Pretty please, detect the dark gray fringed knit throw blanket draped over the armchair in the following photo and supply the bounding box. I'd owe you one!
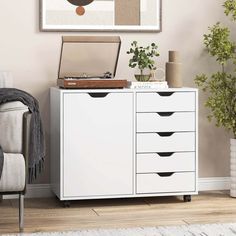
[0,88,45,183]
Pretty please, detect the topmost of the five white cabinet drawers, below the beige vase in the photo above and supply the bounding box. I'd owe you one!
[137,92,196,112]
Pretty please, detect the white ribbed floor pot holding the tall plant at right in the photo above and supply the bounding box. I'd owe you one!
[230,139,236,197]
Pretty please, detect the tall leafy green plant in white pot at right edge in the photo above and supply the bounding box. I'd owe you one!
[195,0,236,197]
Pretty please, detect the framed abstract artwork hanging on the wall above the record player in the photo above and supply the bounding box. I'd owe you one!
[40,0,161,31]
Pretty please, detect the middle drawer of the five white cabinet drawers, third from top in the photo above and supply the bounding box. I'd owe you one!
[137,132,195,153]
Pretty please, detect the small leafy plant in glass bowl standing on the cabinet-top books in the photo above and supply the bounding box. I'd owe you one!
[127,41,160,81]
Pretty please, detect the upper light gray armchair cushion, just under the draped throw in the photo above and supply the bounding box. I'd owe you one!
[0,102,28,153]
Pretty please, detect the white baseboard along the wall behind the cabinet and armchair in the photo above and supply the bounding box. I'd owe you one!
[1,177,230,199]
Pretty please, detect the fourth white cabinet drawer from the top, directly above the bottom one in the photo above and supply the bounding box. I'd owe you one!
[137,152,195,173]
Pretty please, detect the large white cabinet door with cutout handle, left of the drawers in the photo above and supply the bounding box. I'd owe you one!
[63,93,133,197]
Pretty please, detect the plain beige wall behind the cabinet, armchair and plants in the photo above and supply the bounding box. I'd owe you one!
[0,0,232,183]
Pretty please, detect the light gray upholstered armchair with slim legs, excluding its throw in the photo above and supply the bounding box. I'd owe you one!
[0,102,31,230]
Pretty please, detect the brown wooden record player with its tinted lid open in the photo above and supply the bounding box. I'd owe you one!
[57,36,128,89]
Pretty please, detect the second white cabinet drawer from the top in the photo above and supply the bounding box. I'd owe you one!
[137,112,195,132]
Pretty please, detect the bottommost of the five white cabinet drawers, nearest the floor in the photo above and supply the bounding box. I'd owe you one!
[137,172,196,193]
